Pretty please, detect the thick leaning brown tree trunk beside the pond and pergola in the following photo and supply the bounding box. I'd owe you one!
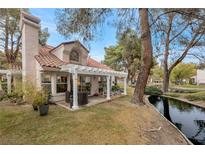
[132,8,152,105]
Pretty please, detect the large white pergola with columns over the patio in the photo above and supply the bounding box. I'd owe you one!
[61,64,128,109]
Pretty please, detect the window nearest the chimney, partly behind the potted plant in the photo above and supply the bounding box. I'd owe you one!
[41,73,51,93]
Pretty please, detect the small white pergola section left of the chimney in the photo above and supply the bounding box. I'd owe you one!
[0,70,21,93]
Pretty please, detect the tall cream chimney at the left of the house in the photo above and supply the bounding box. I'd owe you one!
[20,12,40,85]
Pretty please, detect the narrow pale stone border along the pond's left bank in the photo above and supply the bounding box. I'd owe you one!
[145,96,193,145]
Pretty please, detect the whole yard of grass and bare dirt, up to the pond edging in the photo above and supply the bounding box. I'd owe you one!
[0,93,186,144]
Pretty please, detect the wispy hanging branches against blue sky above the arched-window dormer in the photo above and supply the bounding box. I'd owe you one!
[56,8,112,41]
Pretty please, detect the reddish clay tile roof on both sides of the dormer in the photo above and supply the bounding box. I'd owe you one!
[35,45,112,70]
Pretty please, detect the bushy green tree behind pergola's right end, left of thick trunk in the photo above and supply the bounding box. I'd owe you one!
[104,29,141,79]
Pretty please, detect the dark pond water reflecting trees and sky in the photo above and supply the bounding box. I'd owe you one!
[149,96,205,145]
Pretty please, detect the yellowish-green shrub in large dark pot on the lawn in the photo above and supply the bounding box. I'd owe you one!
[33,90,49,116]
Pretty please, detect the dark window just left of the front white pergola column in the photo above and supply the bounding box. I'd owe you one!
[56,75,67,93]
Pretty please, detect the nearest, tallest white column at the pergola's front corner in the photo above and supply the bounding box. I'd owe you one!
[72,72,79,109]
